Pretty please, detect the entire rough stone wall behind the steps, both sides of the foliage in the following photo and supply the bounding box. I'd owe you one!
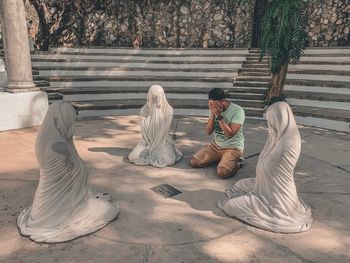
[0,0,350,48]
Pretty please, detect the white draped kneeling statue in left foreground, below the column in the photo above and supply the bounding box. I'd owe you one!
[17,101,119,243]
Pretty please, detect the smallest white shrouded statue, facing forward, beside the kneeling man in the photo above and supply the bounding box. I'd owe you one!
[129,85,182,167]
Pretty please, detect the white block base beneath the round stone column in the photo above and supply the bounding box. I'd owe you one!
[0,91,49,131]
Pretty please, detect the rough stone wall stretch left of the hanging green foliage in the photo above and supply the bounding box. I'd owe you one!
[26,0,253,48]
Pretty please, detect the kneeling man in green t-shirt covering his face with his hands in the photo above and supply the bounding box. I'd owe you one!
[191,88,245,178]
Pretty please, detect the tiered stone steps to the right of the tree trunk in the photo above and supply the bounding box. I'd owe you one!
[285,48,350,132]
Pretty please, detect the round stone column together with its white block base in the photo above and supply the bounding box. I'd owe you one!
[0,0,48,131]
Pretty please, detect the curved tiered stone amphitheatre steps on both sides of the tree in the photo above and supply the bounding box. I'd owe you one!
[32,47,350,131]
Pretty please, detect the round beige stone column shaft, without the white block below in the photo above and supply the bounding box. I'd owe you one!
[1,0,39,93]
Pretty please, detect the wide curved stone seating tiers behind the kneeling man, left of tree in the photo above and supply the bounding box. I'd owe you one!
[32,47,263,118]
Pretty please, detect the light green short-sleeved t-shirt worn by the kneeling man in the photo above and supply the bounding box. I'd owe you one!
[214,102,245,151]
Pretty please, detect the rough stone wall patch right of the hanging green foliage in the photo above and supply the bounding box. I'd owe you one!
[307,0,350,47]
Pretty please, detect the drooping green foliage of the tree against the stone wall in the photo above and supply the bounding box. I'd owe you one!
[260,0,309,74]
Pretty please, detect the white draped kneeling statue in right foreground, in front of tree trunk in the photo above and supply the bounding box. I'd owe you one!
[217,102,313,233]
